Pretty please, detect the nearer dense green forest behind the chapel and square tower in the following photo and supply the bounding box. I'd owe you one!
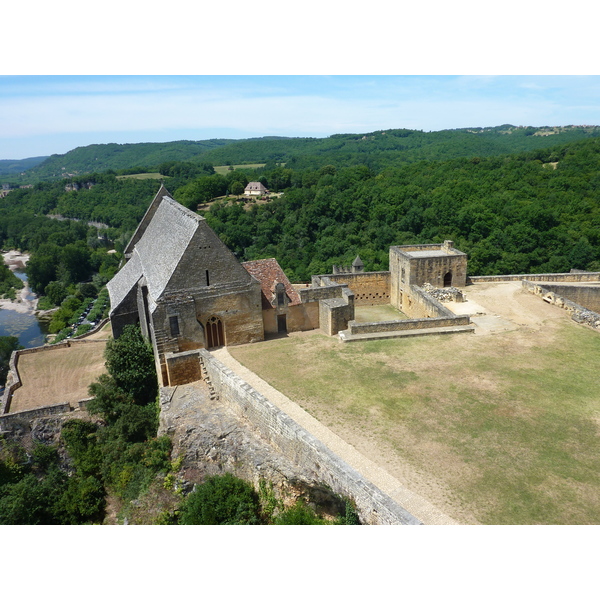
[0,136,600,281]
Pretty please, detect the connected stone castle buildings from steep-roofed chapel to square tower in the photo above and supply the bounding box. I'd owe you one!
[108,184,472,386]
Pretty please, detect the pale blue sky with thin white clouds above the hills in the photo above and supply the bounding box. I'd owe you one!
[0,75,600,159]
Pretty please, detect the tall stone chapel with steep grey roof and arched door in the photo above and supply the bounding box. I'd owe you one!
[107,186,264,385]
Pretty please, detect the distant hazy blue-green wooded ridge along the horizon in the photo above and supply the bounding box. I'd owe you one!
[0,125,600,183]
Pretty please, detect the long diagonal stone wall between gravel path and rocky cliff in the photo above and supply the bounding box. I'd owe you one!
[198,350,421,525]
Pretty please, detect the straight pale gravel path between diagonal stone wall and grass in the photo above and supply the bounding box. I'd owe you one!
[212,348,458,525]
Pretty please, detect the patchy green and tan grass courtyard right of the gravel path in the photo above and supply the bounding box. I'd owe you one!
[229,284,600,524]
